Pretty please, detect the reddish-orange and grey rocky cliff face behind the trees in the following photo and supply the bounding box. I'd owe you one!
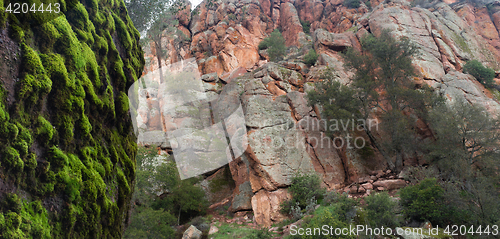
[139,0,500,226]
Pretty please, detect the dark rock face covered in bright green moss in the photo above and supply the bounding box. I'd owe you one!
[0,0,144,238]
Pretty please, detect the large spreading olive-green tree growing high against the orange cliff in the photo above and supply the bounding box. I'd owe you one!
[308,30,440,172]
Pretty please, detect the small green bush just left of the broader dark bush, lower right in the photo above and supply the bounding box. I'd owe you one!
[364,192,399,228]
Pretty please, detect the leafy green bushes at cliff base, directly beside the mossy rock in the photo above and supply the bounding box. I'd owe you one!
[126,147,208,238]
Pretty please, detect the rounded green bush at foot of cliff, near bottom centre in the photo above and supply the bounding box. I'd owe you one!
[281,174,325,216]
